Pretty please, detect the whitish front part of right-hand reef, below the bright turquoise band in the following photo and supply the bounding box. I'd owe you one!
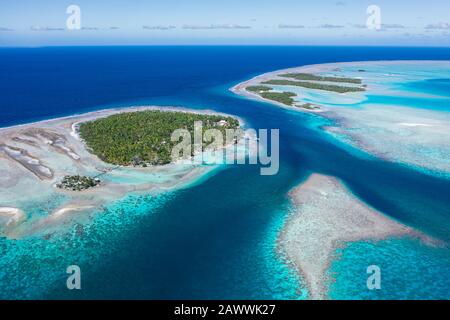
[325,104,450,177]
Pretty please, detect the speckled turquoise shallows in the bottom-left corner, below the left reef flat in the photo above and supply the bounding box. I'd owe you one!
[0,194,171,299]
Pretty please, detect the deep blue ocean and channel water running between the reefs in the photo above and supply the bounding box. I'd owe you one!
[0,46,450,299]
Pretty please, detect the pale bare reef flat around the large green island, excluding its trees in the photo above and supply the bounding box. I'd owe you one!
[0,106,241,239]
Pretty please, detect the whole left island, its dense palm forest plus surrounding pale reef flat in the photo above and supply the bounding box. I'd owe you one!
[0,106,241,239]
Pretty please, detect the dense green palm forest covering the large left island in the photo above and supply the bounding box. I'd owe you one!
[79,110,239,167]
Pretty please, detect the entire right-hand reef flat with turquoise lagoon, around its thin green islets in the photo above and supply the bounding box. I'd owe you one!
[231,61,450,176]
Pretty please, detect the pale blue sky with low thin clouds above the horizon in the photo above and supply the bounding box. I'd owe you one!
[0,0,450,46]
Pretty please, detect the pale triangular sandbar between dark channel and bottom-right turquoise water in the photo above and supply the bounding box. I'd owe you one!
[279,174,434,300]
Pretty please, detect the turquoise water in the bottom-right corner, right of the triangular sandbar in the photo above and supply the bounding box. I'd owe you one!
[329,238,450,300]
